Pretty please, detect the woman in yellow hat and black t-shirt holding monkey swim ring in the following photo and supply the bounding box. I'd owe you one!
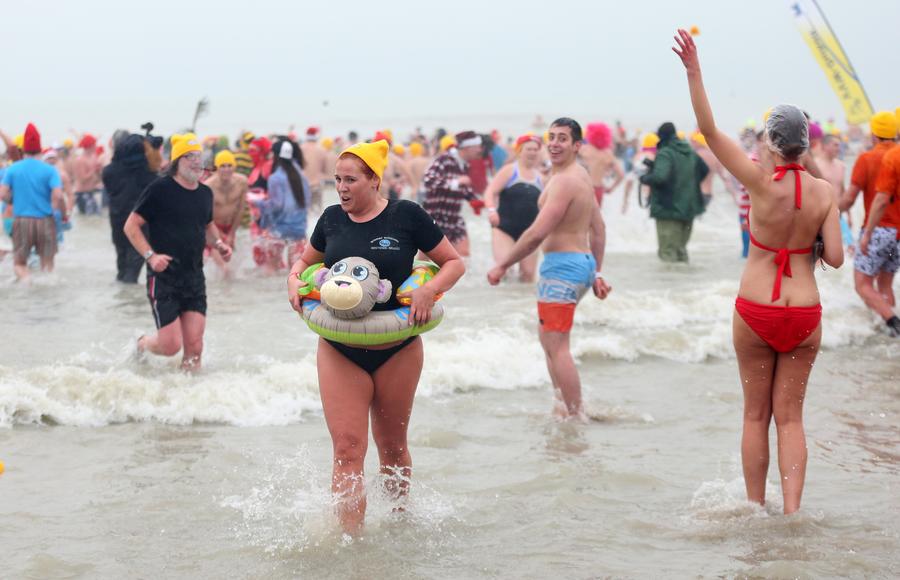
[287,140,465,534]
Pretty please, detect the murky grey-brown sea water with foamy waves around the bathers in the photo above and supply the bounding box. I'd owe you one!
[0,184,900,578]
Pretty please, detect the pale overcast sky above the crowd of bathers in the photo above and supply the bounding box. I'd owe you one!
[0,0,900,140]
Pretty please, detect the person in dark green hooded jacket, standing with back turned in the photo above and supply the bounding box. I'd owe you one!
[641,123,709,262]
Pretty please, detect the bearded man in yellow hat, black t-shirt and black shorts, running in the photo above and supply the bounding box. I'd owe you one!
[124,133,231,371]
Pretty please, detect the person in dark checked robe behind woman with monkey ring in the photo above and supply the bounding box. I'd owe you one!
[423,131,482,257]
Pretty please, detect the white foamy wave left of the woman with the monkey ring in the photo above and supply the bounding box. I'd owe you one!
[0,356,321,427]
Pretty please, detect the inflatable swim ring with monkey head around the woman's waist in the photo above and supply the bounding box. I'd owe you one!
[298,257,444,346]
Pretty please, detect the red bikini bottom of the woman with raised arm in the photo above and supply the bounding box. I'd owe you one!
[734,297,822,352]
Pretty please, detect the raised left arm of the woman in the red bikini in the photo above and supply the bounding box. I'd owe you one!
[672,28,765,190]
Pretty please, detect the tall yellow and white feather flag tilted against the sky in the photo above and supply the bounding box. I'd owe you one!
[789,0,874,125]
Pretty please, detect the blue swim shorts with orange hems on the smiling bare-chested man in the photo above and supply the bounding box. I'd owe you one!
[537,252,597,332]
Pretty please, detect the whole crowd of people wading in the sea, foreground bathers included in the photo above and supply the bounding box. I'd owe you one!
[0,31,900,531]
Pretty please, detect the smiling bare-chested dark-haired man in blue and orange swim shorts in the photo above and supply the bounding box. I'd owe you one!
[488,117,612,420]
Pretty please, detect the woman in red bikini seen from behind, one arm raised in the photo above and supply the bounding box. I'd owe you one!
[672,30,844,514]
